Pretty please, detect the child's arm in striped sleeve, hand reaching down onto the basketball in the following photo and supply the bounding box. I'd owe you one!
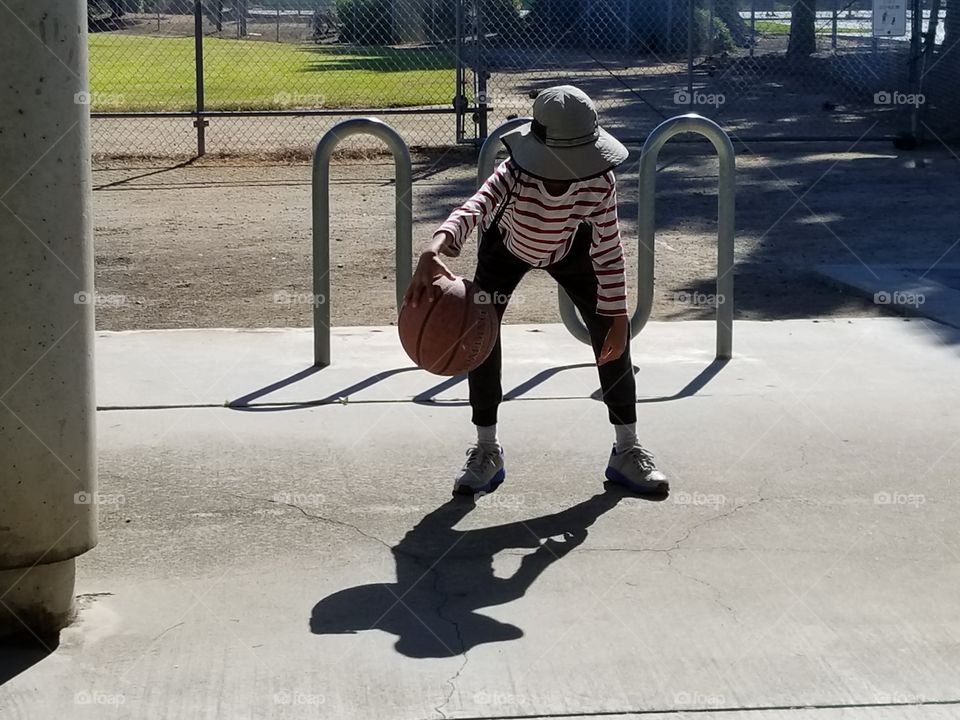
[405,160,516,307]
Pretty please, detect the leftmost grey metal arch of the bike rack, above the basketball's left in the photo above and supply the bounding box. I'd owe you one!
[313,118,413,367]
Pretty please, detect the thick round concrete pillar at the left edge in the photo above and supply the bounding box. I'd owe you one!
[0,0,97,638]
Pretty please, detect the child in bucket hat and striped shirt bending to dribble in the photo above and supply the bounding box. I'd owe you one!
[407,85,669,494]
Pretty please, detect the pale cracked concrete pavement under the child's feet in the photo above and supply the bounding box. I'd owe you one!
[0,318,960,720]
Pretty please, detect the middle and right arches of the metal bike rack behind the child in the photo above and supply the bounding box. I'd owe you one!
[478,113,736,358]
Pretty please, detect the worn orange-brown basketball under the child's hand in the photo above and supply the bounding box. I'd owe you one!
[397,277,500,375]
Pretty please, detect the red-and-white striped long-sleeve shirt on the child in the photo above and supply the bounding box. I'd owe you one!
[437,159,627,316]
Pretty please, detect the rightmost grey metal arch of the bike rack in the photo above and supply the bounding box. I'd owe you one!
[630,113,736,359]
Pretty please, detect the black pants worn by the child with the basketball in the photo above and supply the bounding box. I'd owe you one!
[468,224,637,426]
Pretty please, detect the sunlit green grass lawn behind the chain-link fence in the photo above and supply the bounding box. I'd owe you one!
[89,33,454,111]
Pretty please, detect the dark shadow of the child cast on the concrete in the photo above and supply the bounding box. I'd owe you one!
[310,484,665,658]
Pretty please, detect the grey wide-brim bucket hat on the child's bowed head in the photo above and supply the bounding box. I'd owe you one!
[502,85,629,181]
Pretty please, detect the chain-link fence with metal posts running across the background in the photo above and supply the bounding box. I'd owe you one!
[89,0,960,155]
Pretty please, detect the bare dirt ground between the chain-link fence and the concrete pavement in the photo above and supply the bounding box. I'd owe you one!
[93,143,960,330]
